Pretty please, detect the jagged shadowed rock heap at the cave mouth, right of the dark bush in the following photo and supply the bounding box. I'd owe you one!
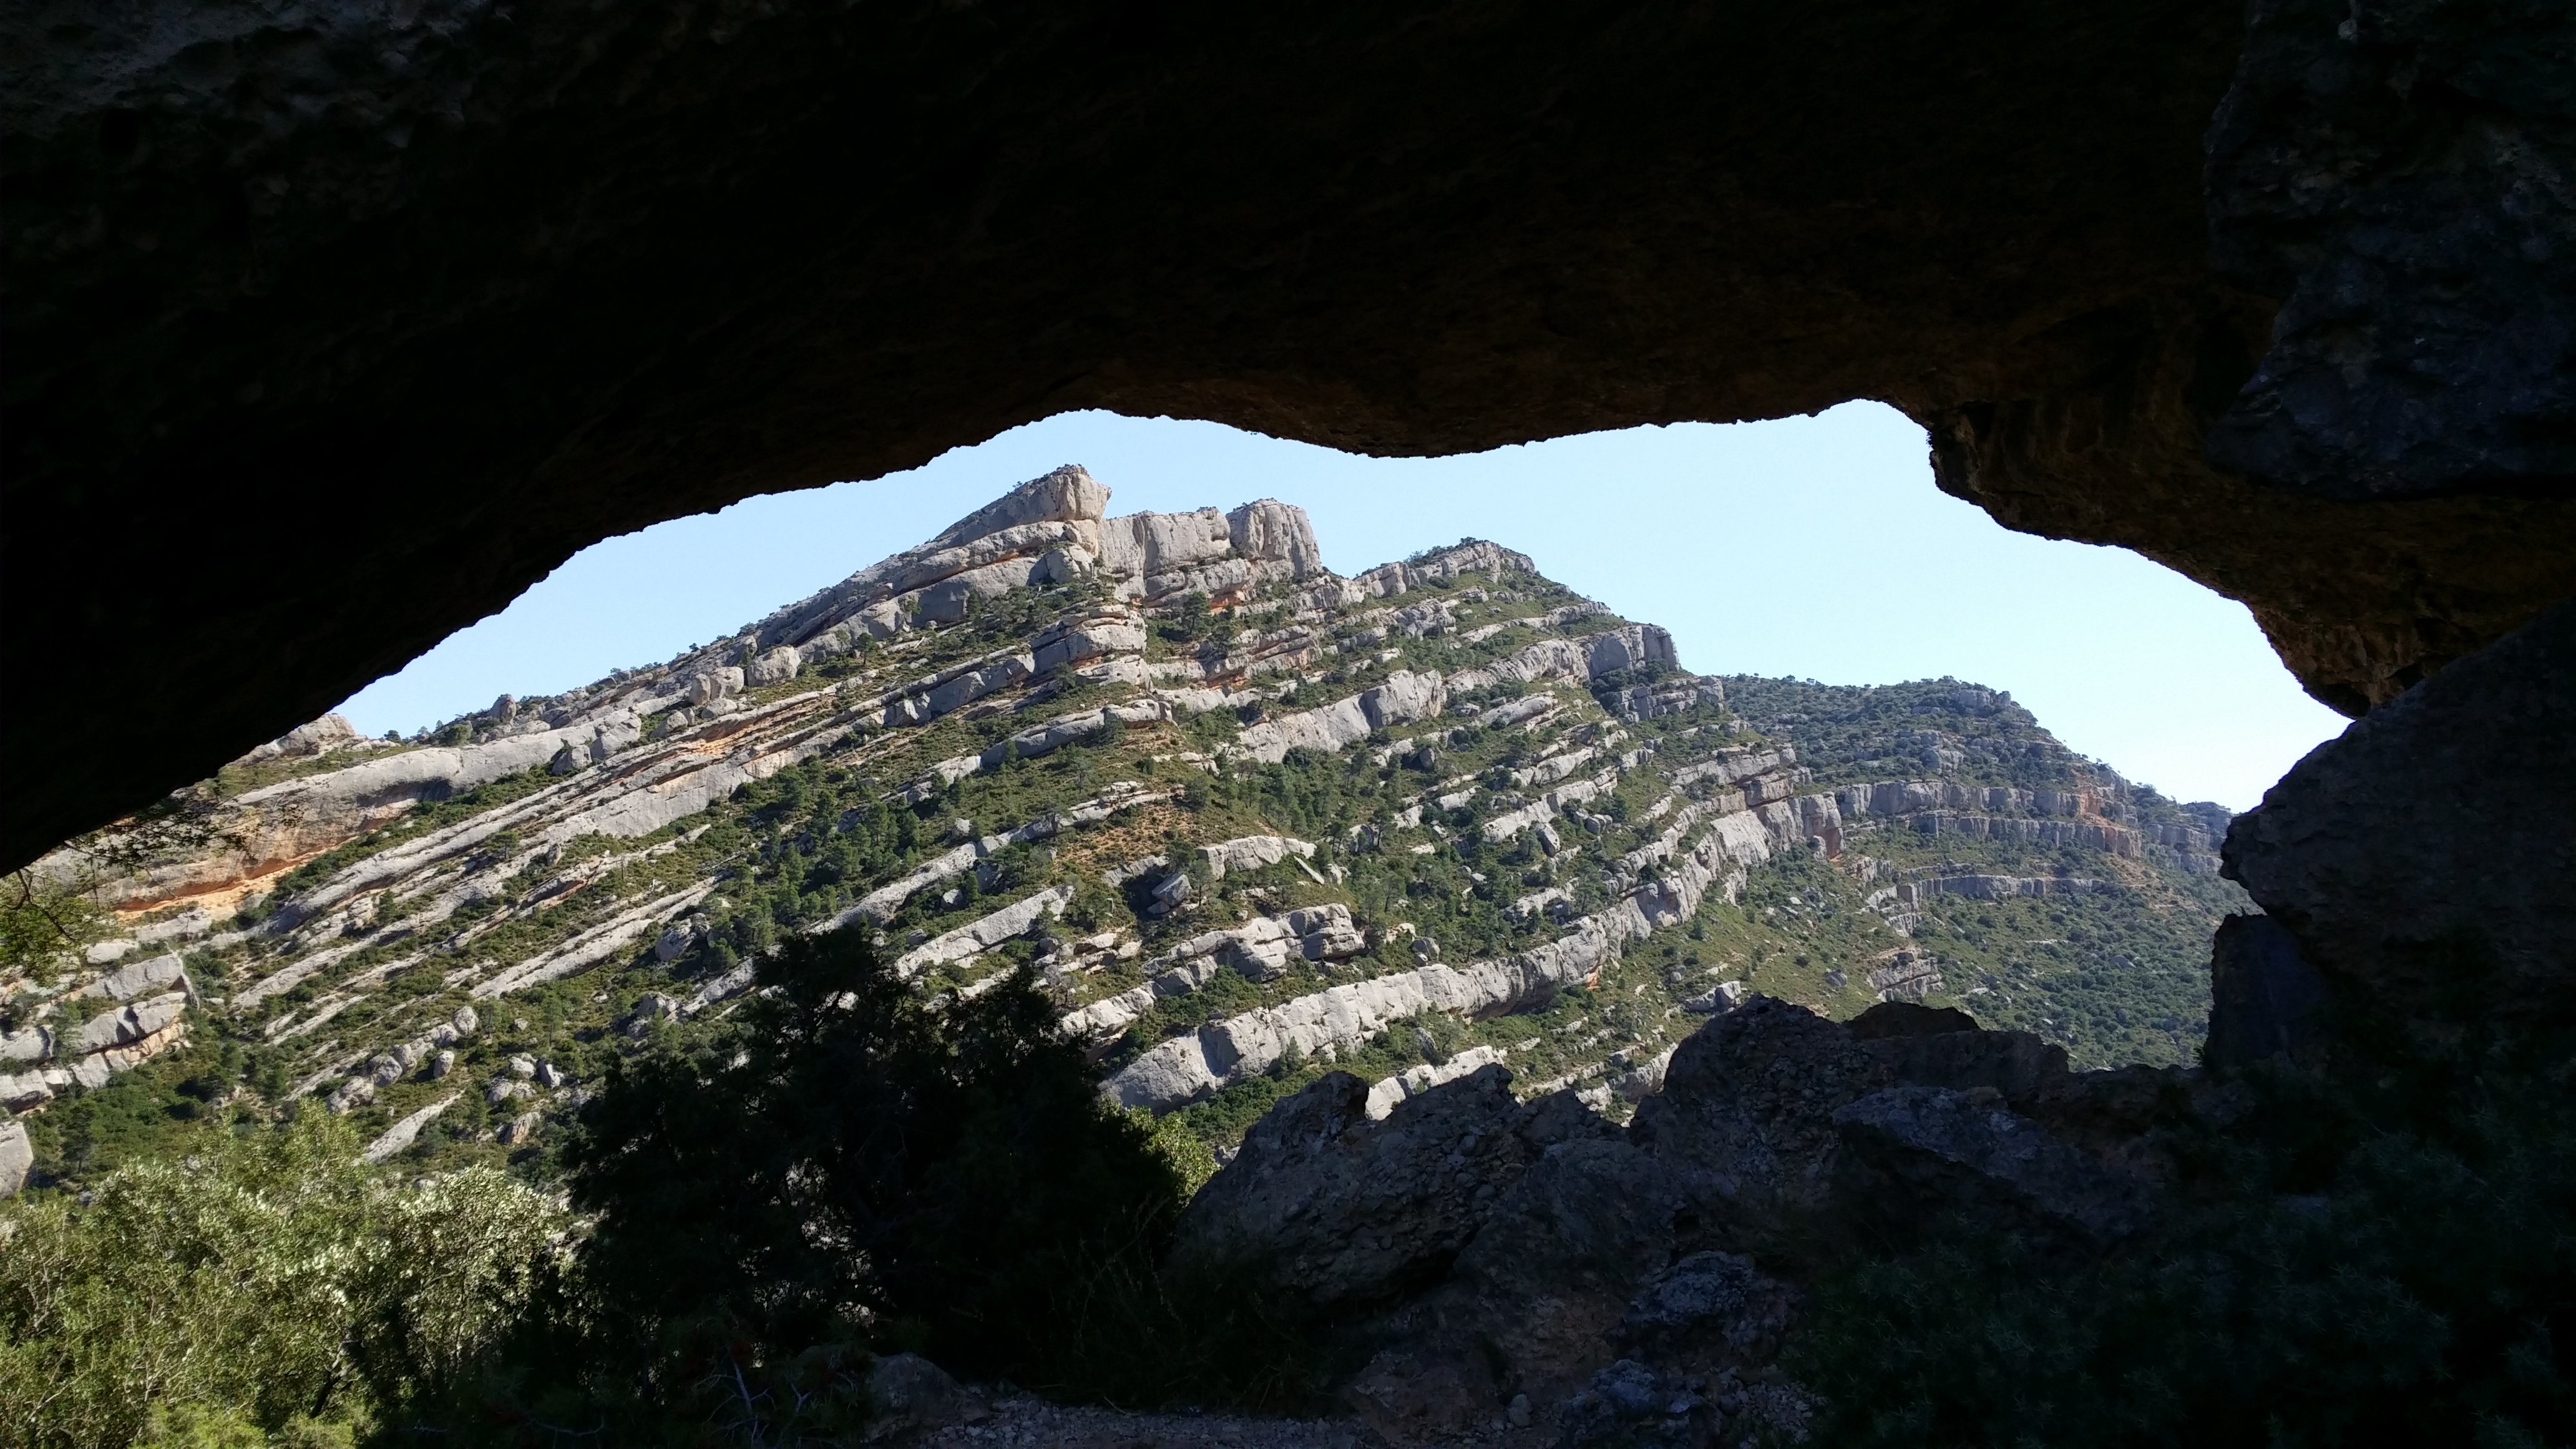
[1172,995,2205,1447]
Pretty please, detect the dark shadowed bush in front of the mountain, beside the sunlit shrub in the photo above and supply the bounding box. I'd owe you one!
[494,912,1306,1444]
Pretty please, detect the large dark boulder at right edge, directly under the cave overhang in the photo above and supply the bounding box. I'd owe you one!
[2220,601,2576,1023]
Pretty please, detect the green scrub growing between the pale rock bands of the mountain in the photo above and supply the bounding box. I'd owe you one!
[10,564,2238,1196]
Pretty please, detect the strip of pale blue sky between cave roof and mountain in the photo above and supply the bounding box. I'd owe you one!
[340,402,2344,809]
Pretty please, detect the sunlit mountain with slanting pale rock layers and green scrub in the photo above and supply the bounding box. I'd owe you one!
[0,467,2236,1176]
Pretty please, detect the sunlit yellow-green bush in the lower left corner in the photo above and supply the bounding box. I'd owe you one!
[0,1114,562,1449]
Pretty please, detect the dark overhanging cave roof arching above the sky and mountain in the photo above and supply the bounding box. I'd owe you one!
[0,0,2576,864]
